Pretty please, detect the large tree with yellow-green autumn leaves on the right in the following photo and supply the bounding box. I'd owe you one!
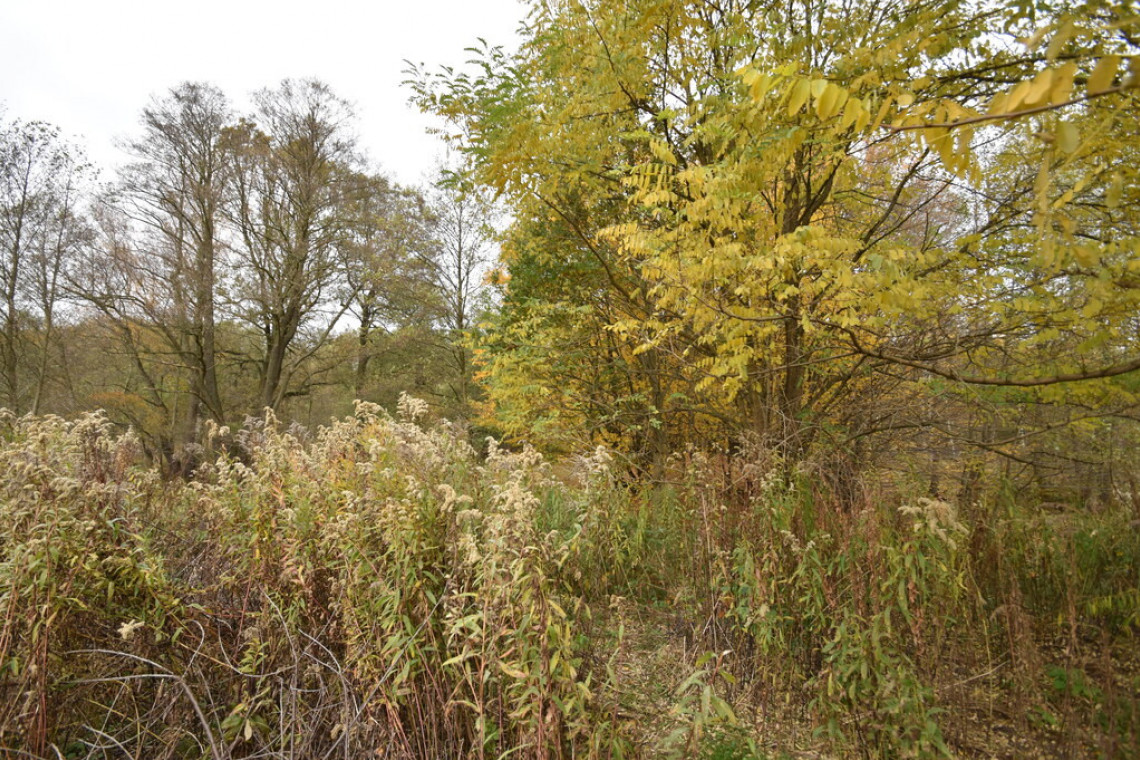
[417,0,1140,487]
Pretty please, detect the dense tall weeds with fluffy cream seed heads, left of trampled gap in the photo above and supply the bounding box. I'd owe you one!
[0,407,620,757]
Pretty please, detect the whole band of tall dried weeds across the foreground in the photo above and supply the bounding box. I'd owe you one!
[0,398,1140,758]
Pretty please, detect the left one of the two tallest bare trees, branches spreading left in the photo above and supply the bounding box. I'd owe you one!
[72,82,233,469]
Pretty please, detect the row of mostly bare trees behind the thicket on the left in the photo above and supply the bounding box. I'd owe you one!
[0,80,492,468]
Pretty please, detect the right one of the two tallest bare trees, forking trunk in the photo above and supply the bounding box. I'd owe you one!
[233,80,369,409]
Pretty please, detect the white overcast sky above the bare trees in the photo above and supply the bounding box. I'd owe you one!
[0,0,526,183]
